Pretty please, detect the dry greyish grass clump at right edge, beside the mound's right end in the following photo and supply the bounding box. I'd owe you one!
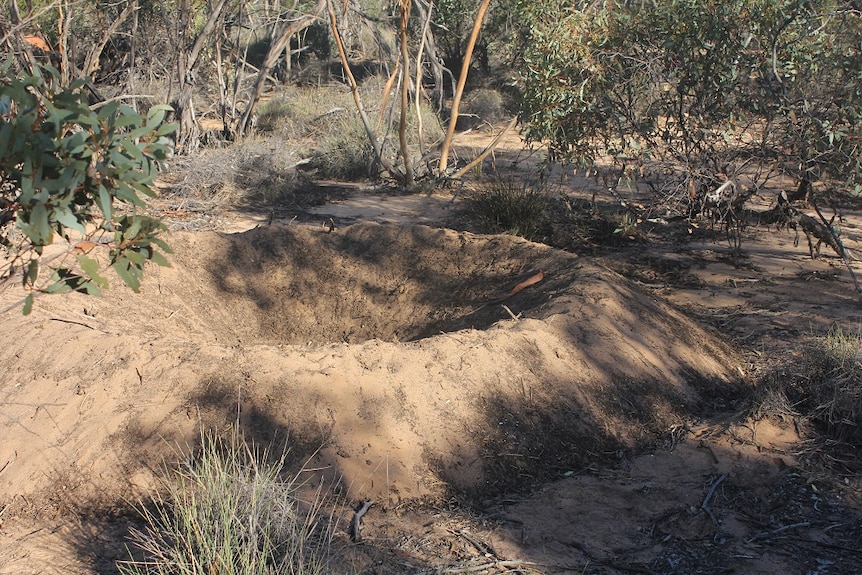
[757,327,862,447]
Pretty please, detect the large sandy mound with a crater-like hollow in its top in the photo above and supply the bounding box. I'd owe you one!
[0,224,739,506]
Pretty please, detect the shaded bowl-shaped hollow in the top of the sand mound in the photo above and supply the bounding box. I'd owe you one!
[160,224,577,344]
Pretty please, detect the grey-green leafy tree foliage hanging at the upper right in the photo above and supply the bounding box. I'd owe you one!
[519,0,862,205]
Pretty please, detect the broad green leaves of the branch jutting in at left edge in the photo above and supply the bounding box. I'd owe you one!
[0,60,174,313]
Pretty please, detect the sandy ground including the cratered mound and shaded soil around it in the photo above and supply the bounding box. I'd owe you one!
[0,133,862,575]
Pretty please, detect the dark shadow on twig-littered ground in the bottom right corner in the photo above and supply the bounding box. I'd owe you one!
[490,430,862,574]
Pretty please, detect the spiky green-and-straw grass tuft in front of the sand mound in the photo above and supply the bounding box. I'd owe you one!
[117,432,335,575]
